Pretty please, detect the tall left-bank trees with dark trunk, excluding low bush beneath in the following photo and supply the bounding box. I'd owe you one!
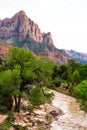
[0,47,54,112]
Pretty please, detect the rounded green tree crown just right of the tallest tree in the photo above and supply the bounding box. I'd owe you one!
[35,57,55,87]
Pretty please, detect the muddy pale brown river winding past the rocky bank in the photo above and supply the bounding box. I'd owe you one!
[51,91,87,130]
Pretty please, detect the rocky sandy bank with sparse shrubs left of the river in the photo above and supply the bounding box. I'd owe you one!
[0,95,63,130]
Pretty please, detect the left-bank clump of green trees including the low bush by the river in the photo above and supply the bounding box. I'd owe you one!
[0,47,54,112]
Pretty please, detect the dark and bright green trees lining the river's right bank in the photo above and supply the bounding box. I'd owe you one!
[52,60,87,111]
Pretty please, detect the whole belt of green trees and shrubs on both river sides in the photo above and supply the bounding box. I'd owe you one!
[0,47,87,130]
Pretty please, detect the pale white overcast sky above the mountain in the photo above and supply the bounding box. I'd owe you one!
[0,0,87,53]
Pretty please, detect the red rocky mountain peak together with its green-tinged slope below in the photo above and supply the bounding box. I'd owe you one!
[0,11,71,64]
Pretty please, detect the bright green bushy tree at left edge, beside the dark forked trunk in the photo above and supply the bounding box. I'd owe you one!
[0,69,20,110]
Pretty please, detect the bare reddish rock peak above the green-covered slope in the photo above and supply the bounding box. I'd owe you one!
[0,11,53,46]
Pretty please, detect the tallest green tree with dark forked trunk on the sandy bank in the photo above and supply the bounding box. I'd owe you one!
[5,47,35,112]
